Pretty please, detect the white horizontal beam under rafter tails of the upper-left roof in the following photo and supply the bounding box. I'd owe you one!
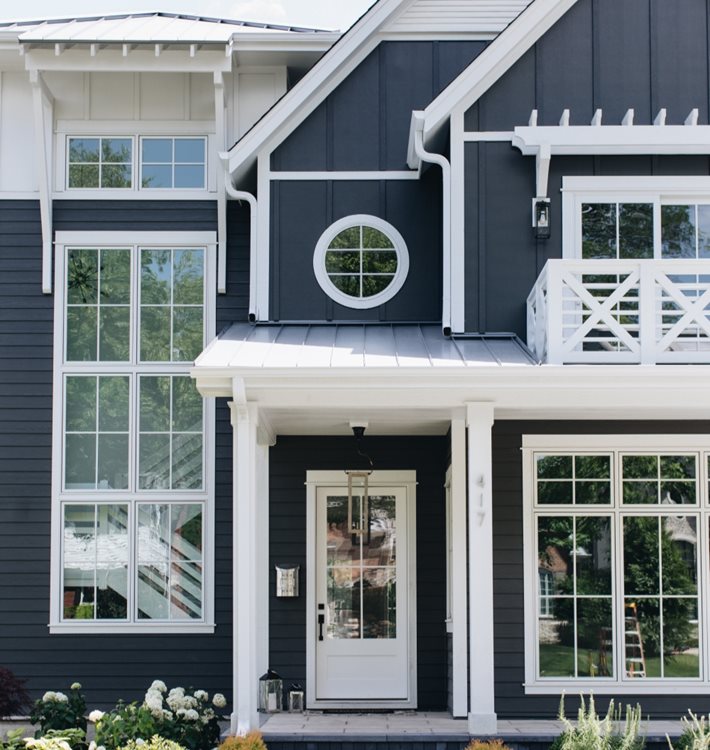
[25,43,232,73]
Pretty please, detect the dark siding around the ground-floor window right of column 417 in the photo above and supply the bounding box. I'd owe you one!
[493,421,710,719]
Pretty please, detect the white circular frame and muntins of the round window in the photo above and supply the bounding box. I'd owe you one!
[313,214,409,310]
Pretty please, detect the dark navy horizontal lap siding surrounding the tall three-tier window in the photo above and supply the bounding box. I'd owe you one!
[0,200,249,708]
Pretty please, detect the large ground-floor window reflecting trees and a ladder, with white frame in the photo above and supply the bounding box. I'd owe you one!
[523,435,710,694]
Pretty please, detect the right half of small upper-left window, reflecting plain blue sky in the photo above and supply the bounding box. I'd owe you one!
[140,136,207,190]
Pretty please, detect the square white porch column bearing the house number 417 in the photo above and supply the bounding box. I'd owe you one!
[466,403,497,734]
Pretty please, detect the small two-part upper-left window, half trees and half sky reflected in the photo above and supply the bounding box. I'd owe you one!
[64,134,208,193]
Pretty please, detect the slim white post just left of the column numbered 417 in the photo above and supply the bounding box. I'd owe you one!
[449,418,468,718]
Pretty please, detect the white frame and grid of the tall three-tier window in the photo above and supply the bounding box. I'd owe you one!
[50,232,217,633]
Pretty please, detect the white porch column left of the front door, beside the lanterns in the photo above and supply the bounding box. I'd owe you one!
[230,378,270,734]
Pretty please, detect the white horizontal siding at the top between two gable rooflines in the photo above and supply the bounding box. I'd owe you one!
[384,0,531,34]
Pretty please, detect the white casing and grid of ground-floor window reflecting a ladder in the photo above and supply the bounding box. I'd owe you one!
[523,434,710,695]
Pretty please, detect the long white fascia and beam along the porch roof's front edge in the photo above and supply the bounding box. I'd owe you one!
[190,365,710,420]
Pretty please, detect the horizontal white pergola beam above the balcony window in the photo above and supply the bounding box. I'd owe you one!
[512,125,710,156]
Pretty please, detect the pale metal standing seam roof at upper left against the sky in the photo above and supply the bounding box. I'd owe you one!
[0,12,330,44]
